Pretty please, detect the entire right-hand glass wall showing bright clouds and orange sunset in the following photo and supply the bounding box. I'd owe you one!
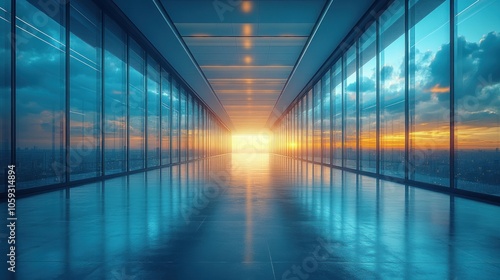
[273,0,500,199]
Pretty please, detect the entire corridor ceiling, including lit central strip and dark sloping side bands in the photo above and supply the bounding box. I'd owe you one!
[113,0,374,133]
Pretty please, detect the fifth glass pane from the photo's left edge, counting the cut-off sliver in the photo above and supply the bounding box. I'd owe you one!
[128,38,146,170]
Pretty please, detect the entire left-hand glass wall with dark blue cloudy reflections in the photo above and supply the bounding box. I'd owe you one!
[0,0,230,193]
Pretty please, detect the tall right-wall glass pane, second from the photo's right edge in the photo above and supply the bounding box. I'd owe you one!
[408,0,450,186]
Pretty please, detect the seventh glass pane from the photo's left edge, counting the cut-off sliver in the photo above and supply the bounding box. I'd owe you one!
[161,69,172,165]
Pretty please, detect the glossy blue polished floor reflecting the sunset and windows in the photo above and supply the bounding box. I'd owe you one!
[0,154,500,280]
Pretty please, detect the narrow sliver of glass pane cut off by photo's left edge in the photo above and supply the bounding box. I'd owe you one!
[0,0,10,193]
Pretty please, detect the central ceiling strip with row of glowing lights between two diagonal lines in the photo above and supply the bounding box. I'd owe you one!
[162,0,326,131]
